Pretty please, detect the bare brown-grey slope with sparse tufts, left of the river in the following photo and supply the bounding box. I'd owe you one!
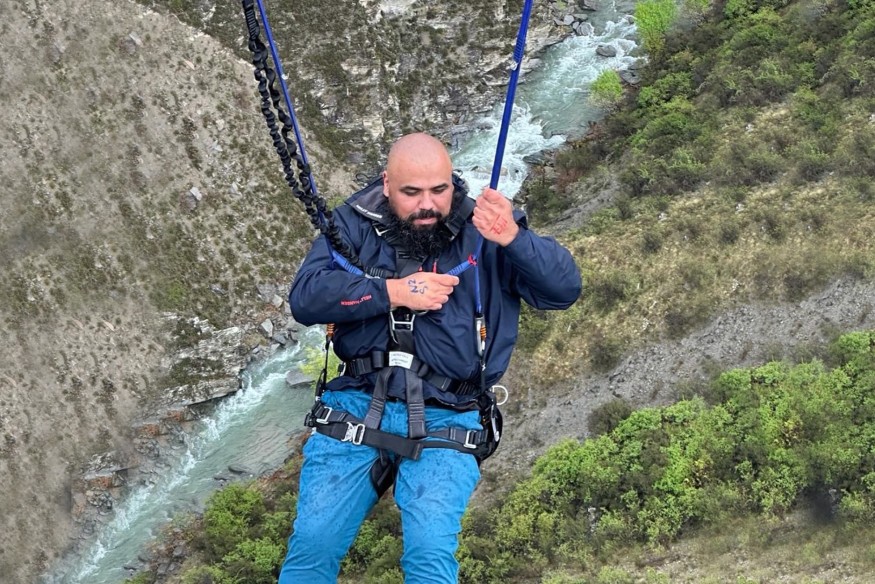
[0,0,342,584]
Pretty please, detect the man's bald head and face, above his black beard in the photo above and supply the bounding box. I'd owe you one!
[383,133,453,228]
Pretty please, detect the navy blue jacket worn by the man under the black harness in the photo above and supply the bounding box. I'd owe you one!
[289,180,581,409]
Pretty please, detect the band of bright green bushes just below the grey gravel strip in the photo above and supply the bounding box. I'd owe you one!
[444,332,875,583]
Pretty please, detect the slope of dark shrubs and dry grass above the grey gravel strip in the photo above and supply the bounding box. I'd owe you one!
[527,1,875,380]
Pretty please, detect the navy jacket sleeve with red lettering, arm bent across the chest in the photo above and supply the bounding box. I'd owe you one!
[289,229,389,326]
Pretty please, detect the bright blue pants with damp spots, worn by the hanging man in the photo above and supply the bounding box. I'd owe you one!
[279,390,481,584]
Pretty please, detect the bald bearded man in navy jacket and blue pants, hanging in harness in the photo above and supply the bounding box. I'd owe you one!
[280,134,581,584]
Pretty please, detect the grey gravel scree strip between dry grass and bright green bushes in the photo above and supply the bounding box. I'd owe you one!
[484,280,875,492]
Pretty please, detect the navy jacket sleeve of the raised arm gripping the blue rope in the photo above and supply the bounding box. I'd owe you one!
[504,221,582,310]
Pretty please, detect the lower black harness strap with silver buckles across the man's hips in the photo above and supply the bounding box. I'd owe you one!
[304,402,490,460]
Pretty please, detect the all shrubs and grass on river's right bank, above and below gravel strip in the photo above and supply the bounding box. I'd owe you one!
[125,0,875,584]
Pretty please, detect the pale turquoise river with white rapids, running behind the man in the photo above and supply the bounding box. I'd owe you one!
[54,3,636,584]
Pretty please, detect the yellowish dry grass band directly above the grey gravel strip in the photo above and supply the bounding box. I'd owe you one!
[535,173,875,382]
